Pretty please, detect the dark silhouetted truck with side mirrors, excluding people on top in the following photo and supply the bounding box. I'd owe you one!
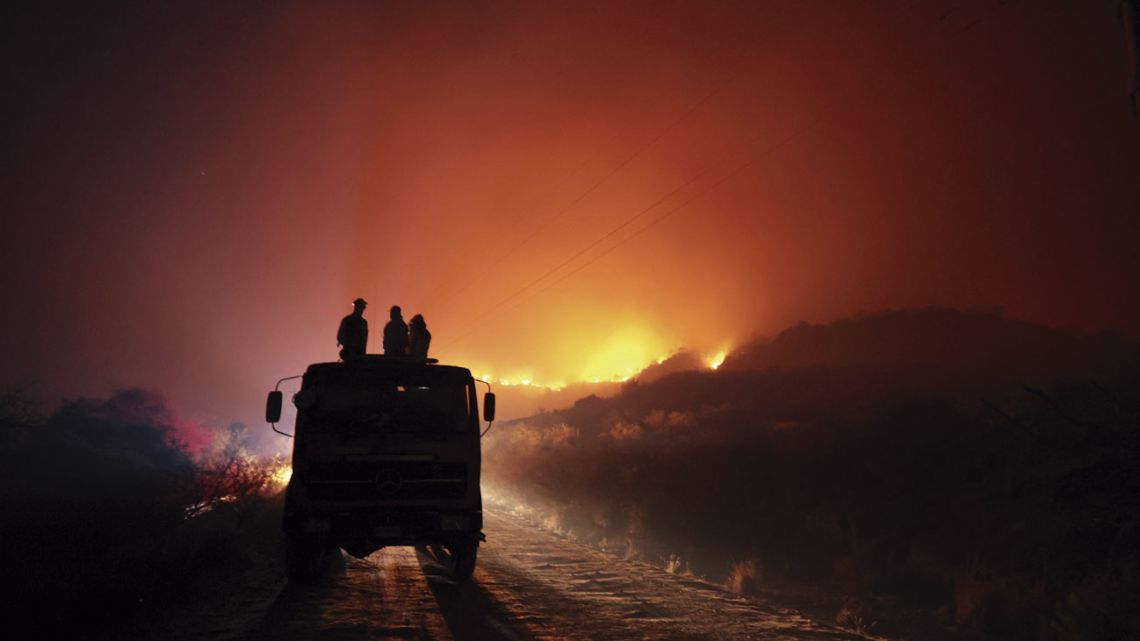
[266,355,495,581]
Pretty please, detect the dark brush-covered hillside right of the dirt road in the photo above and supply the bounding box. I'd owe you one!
[485,307,1140,639]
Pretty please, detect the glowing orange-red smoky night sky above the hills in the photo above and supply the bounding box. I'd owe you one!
[0,0,1140,424]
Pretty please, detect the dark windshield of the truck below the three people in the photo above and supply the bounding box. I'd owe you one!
[298,376,471,432]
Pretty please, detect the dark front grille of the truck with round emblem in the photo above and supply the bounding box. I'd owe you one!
[306,462,467,501]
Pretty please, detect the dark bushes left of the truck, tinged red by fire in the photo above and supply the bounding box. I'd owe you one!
[0,390,277,639]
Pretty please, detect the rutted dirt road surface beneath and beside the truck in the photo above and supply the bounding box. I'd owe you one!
[238,512,863,641]
